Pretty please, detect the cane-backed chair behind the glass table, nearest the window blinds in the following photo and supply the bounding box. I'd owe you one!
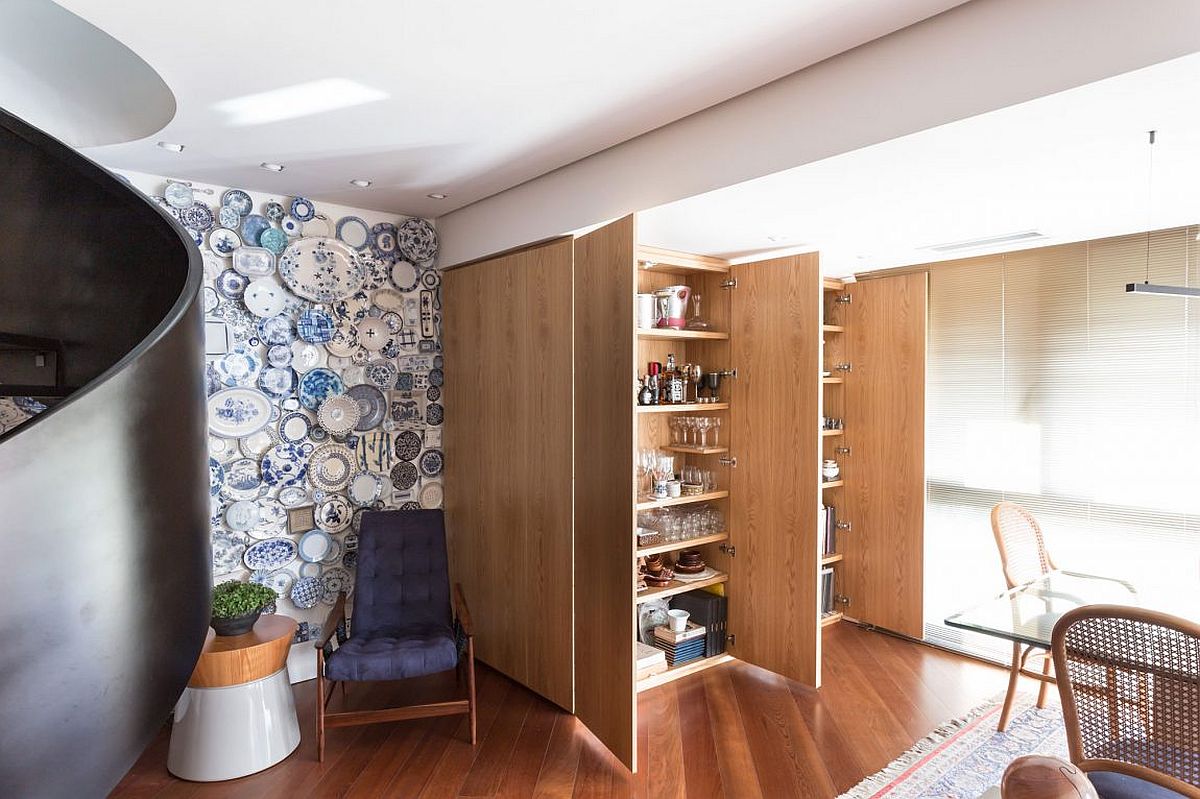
[991,503,1055,732]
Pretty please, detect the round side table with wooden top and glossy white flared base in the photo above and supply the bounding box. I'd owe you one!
[167,614,300,782]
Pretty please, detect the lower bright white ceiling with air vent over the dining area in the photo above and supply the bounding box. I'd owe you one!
[638,54,1200,275]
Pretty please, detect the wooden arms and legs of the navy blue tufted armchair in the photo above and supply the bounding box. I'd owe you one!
[317,583,476,762]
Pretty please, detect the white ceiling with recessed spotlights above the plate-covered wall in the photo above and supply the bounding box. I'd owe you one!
[58,0,962,216]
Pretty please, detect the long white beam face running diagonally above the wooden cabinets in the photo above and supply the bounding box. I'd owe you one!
[438,0,1200,266]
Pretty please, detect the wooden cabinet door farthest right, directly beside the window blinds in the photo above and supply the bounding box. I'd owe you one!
[842,272,926,638]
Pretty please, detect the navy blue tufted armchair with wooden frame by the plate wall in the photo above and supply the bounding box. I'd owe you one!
[317,510,475,759]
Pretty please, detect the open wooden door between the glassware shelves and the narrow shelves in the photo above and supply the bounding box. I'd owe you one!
[726,253,821,686]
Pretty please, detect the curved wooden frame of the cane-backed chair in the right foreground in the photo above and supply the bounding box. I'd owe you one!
[1050,605,1200,799]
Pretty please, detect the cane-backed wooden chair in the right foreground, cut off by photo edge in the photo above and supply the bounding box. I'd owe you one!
[1051,605,1200,799]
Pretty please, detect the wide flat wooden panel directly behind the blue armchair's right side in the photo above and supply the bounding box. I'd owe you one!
[442,239,572,709]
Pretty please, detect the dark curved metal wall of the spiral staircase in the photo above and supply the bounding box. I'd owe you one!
[0,112,211,797]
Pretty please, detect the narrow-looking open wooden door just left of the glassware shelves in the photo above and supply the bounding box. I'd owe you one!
[571,216,637,770]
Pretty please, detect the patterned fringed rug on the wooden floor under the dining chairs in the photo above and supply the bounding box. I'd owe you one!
[838,695,1067,799]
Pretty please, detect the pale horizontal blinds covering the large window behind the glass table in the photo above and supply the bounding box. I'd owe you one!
[925,227,1200,661]
